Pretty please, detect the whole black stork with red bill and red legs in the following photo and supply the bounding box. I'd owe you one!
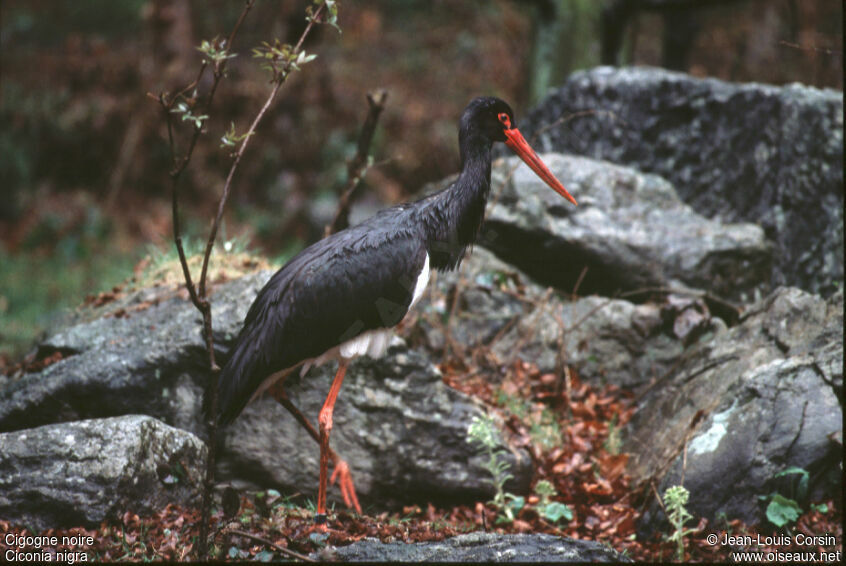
[216,97,576,528]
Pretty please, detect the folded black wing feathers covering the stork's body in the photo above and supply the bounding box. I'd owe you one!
[210,221,428,425]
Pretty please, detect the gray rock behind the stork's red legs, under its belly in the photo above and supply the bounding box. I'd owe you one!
[218,344,533,507]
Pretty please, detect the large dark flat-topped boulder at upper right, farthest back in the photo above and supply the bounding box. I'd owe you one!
[518,67,844,295]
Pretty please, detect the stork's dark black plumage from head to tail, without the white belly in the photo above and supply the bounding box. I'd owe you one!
[212,98,512,425]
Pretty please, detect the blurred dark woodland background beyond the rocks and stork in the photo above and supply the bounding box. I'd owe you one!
[0,0,843,357]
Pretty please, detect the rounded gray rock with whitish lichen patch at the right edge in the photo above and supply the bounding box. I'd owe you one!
[624,288,843,529]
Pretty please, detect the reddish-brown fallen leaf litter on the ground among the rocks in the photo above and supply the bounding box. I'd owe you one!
[0,362,843,562]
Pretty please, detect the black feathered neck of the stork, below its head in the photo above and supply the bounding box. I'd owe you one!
[421,129,492,270]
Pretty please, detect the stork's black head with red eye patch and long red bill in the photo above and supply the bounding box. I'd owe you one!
[461,96,578,204]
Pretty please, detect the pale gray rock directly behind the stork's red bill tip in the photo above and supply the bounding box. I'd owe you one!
[480,154,772,302]
